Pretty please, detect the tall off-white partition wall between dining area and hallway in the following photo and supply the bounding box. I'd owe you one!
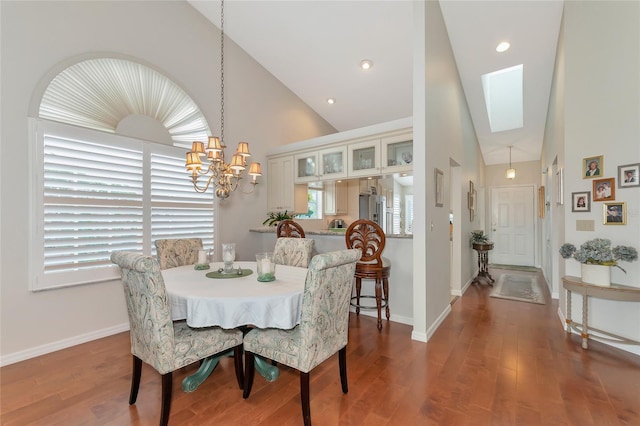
[413,2,484,340]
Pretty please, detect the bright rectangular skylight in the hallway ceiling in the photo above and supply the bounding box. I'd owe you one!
[482,64,524,133]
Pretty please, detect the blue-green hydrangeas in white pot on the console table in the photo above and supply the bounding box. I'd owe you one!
[560,238,638,287]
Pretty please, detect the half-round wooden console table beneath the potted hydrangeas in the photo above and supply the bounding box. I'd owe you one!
[562,276,640,349]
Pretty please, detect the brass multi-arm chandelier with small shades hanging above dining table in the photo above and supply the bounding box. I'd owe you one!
[185,0,262,199]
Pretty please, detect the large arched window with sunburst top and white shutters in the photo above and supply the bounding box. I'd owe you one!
[29,58,214,291]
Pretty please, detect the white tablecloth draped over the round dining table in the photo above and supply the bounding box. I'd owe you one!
[162,262,307,329]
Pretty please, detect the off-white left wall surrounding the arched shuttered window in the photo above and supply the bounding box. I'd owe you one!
[0,1,334,363]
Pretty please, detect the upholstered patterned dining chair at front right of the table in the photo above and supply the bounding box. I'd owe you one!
[243,250,361,425]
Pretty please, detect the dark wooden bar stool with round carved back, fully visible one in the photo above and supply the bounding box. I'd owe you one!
[345,219,391,330]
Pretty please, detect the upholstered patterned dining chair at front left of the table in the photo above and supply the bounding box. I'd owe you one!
[111,251,244,425]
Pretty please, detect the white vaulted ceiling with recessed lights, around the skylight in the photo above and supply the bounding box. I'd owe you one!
[189,0,563,165]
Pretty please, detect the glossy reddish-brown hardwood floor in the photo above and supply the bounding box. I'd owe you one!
[0,270,640,426]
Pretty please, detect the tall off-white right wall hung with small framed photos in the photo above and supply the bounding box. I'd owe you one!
[545,1,640,354]
